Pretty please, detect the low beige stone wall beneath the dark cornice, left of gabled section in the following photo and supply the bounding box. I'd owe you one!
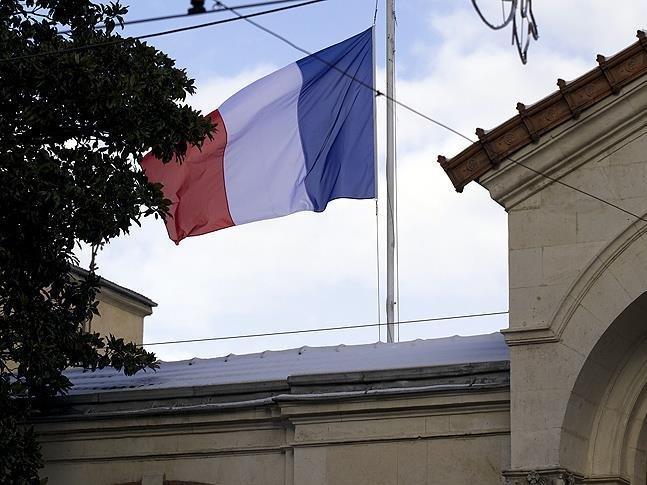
[37,390,510,485]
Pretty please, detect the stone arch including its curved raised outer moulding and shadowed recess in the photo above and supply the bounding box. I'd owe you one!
[550,216,647,485]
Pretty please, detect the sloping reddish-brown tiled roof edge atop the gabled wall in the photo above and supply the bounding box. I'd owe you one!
[438,30,647,192]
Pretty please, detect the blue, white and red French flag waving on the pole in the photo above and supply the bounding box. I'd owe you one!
[141,28,376,243]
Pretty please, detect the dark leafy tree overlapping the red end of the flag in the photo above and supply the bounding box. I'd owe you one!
[0,0,213,484]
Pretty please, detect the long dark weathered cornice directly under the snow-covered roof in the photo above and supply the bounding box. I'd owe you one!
[34,361,510,425]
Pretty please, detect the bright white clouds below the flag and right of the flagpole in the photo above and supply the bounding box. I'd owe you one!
[81,0,647,360]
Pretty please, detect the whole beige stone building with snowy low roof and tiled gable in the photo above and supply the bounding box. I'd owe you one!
[37,32,647,485]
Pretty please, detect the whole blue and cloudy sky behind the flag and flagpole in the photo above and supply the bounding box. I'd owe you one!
[80,0,647,360]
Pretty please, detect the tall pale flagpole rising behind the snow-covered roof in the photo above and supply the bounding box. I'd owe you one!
[386,0,397,342]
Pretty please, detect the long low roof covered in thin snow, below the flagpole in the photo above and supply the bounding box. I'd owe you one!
[66,332,510,396]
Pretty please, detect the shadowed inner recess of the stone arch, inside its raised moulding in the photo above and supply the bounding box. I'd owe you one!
[560,292,647,485]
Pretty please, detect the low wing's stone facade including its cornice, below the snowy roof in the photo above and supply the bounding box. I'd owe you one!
[37,362,510,485]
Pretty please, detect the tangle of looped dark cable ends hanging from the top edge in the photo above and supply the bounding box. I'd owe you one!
[472,0,539,64]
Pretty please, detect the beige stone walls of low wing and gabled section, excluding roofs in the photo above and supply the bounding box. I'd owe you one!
[37,57,647,485]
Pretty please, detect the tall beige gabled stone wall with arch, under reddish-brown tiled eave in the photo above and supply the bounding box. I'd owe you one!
[481,73,647,484]
